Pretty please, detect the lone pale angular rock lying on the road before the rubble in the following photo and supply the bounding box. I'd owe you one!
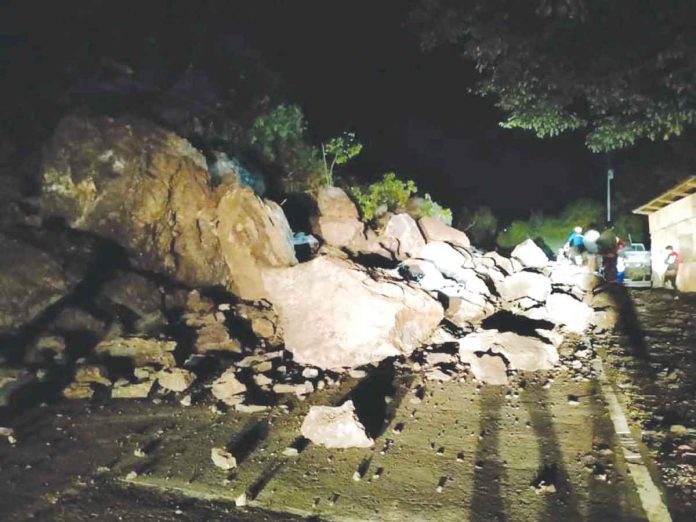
[301,401,374,448]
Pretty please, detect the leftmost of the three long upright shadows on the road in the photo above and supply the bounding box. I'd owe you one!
[469,386,507,522]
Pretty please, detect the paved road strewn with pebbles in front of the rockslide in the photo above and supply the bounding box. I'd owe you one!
[0,288,693,522]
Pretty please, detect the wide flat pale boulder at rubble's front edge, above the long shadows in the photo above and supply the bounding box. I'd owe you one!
[459,330,558,371]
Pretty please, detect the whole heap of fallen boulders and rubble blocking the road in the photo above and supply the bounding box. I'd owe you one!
[0,117,617,450]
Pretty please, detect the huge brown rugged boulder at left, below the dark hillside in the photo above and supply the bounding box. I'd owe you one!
[41,116,296,299]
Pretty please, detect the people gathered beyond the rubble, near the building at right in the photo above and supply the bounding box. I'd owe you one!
[562,226,681,289]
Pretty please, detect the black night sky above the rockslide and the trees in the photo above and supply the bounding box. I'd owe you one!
[0,0,604,217]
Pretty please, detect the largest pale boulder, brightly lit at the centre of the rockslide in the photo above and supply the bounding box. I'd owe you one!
[264,257,443,369]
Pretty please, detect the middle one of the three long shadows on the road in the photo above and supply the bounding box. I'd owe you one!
[521,383,582,521]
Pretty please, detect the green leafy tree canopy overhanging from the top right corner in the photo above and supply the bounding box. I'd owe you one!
[411,0,696,152]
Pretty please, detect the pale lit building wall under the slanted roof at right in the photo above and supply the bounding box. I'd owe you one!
[649,194,696,292]
